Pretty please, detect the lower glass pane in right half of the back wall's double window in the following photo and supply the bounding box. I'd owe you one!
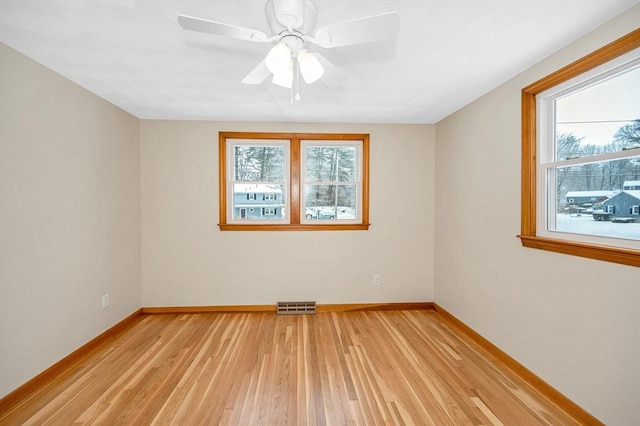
[305,185,357,220]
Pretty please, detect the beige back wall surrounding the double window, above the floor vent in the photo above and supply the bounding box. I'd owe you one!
[140,121,435,306]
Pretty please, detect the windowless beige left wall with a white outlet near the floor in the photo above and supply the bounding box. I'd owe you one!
[0,45,141,396]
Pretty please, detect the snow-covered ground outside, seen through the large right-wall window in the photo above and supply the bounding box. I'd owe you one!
[556,214,640,240]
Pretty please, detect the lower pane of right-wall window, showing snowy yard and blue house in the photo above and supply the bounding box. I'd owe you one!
[555,156,640,240]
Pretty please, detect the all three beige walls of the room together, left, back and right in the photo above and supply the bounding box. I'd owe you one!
[0,7,640,425]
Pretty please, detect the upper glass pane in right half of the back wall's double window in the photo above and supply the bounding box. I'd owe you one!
[305,146,356,182]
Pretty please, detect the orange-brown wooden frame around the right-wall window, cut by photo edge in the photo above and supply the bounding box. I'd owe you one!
[518,29,640,267]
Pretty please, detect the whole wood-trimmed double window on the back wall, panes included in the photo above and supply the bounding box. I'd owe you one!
[219,132,369,231]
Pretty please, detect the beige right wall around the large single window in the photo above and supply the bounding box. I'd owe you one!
[435,6,640,425]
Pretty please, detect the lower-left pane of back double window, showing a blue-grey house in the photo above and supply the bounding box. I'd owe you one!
[232,183,286,220]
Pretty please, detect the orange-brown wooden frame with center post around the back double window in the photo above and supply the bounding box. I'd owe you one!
[218,132,370,231]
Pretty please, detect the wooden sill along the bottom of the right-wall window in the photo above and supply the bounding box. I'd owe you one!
[518,235,640,267]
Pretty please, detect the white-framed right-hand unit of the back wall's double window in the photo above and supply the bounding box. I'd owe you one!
[301,141,362,223]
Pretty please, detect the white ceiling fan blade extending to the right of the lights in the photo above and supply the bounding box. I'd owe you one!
[313,12,400,48]
